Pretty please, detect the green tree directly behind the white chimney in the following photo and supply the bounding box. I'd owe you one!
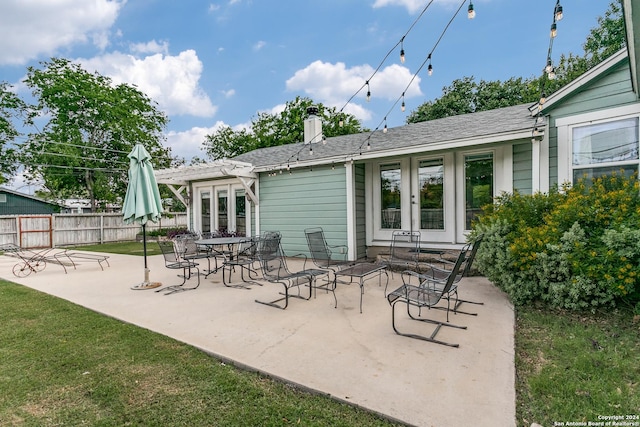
[202,96,363,160]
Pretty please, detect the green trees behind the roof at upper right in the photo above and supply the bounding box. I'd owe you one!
[407,1,625,123]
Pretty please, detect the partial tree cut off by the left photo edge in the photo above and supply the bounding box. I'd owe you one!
[0,82,26,184]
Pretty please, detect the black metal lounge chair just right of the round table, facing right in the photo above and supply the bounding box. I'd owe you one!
[255,232,330,310]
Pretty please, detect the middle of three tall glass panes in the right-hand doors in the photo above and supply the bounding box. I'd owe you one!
[418,159,444,230]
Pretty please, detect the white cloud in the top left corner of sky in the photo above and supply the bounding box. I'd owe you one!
[0,0,126,65]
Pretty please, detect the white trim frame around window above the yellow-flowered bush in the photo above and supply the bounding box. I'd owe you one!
[556,104,640,185]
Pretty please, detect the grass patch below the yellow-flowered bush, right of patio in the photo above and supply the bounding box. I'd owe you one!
[515,307,640,427]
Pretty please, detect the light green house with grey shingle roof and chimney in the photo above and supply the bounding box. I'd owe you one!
[156,0,640,260]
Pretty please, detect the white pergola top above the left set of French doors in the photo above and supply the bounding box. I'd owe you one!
[154,160,257,185]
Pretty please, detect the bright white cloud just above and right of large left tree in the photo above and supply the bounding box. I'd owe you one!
[78,50,217,117]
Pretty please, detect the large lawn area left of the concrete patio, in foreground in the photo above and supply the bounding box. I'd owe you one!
[0,280,400,426]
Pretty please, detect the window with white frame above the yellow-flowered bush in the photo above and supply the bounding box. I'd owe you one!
[571,117,638,182]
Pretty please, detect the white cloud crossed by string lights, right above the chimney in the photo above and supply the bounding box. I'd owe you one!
[286,61,422,121]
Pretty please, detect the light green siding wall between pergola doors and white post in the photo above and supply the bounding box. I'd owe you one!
[258,166,347,256]
